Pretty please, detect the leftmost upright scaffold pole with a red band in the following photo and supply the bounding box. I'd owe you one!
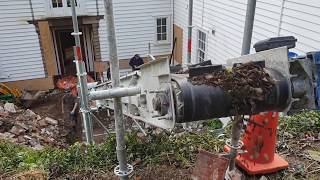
[71,0,93,144]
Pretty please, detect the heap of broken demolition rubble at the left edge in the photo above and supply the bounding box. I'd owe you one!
[0,103,71,149]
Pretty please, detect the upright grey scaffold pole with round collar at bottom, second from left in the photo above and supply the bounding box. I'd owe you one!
[104,0,133,180]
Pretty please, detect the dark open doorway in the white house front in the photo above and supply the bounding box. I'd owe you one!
[53,27,94,76]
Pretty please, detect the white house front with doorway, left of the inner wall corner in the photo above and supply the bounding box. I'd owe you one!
[0,0,173,89]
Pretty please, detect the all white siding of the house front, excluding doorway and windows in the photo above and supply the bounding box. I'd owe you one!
[0,0,172,87]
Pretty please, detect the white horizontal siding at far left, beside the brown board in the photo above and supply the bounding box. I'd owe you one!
[0,0,45,82]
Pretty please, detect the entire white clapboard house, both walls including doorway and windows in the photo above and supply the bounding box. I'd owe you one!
[0,0,320,89]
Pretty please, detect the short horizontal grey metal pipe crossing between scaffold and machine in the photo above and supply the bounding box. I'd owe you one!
[89,87,141,100]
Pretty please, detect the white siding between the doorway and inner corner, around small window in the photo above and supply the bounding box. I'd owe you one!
[97,0,172,61]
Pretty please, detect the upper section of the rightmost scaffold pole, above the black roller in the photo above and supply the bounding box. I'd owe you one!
[241,0,257,55]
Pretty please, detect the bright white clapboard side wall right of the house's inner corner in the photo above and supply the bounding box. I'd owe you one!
[174,0,320,64]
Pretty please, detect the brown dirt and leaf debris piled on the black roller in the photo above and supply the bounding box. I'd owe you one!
[189,63,274,112]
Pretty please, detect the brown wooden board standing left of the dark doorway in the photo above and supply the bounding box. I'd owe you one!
[38,21,58,76]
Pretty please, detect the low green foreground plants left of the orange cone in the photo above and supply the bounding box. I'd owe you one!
[0,131,224,177]
